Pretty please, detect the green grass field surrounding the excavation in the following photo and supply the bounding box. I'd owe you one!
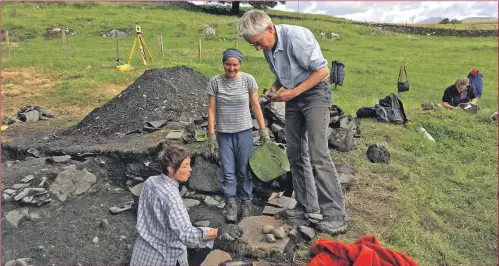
[2,2,498,266]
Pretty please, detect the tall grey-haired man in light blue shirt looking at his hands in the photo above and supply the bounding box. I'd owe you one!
[237,10,347,235]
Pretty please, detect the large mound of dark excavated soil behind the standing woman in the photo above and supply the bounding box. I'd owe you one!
[62,66,209,136]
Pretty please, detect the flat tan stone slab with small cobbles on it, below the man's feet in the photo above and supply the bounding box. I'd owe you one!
[235,216,289,258]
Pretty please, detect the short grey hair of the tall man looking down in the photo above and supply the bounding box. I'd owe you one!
[237,9,274,38]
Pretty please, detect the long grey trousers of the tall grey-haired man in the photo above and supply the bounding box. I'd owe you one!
[286,82,346,220]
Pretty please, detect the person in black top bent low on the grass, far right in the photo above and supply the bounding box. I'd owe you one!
[442,77,477,110]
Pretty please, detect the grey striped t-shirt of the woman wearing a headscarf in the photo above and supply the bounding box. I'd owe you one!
[207,72,258,133]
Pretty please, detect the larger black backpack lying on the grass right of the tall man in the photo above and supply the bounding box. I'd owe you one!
[374,93,408,126]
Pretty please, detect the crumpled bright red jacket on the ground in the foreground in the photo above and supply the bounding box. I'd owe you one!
[308,236,418,266]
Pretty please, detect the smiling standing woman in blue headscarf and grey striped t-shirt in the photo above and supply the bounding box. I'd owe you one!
[207,49,270,222]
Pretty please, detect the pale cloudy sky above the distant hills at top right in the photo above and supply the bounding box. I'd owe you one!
[192,1,498,24]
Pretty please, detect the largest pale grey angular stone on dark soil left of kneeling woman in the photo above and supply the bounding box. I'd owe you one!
[49,165,97,201]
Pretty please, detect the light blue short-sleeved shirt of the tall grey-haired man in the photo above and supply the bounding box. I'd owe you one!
[263,24,327,89]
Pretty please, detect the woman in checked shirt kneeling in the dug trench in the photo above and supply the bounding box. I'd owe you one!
[130,145,243,265]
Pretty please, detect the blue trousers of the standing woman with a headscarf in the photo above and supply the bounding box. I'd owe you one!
[217,129,253,203]
